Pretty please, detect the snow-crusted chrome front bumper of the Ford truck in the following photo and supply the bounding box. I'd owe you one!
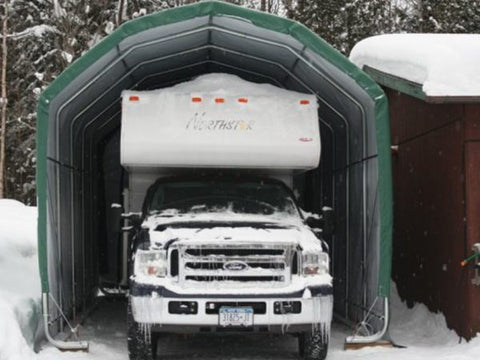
[130,284,333,333]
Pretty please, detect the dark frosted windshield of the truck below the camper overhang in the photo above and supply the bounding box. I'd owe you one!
[145,180,299,216]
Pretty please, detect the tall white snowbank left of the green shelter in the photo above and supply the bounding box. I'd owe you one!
[0,200,41,360]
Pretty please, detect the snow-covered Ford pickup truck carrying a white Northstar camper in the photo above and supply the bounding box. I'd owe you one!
[121,74,333,360]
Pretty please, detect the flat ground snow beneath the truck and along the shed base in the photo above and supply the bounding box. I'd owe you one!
[35,287,480,360]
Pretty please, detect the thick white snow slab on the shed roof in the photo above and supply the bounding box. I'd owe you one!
[350,34,480,96]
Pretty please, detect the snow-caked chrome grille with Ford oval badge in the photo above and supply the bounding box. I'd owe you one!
[169,244,297,286]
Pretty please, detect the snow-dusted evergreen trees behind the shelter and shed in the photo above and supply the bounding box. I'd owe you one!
[0,0,480,204]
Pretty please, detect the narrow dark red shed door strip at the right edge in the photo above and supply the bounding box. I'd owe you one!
[464,104,480,337]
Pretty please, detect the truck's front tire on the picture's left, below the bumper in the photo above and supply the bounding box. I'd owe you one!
[127,301,158,360]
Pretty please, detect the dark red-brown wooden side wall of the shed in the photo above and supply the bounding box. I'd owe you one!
[386,89,470,337]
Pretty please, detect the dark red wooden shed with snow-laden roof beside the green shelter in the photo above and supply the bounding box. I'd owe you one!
[352,35,480,339]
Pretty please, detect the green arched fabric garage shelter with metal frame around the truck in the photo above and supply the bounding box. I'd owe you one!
[37,2,392,348]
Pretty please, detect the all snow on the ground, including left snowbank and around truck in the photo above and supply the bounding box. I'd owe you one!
[0,200,480,360]
